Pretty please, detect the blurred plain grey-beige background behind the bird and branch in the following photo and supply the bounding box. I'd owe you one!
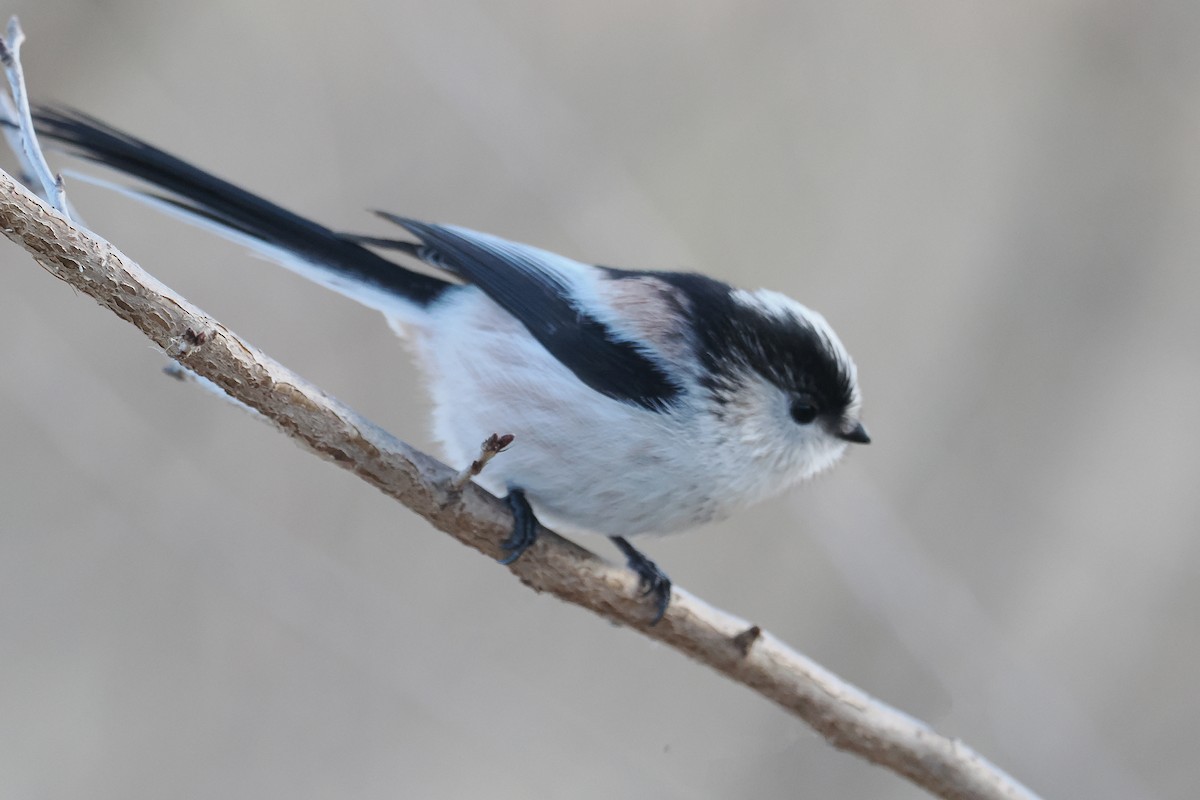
[0,0,1200,800]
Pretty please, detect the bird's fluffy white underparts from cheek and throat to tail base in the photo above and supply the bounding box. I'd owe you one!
[392,287,840,536]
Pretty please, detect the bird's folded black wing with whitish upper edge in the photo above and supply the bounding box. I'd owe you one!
[372,211,683,411]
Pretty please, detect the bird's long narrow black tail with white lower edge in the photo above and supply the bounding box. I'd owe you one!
[34,107,451,313]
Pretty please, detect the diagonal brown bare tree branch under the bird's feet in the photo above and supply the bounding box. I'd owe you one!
[0,38,1037,800]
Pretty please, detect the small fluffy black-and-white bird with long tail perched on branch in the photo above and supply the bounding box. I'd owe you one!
[35,108,870,624]
